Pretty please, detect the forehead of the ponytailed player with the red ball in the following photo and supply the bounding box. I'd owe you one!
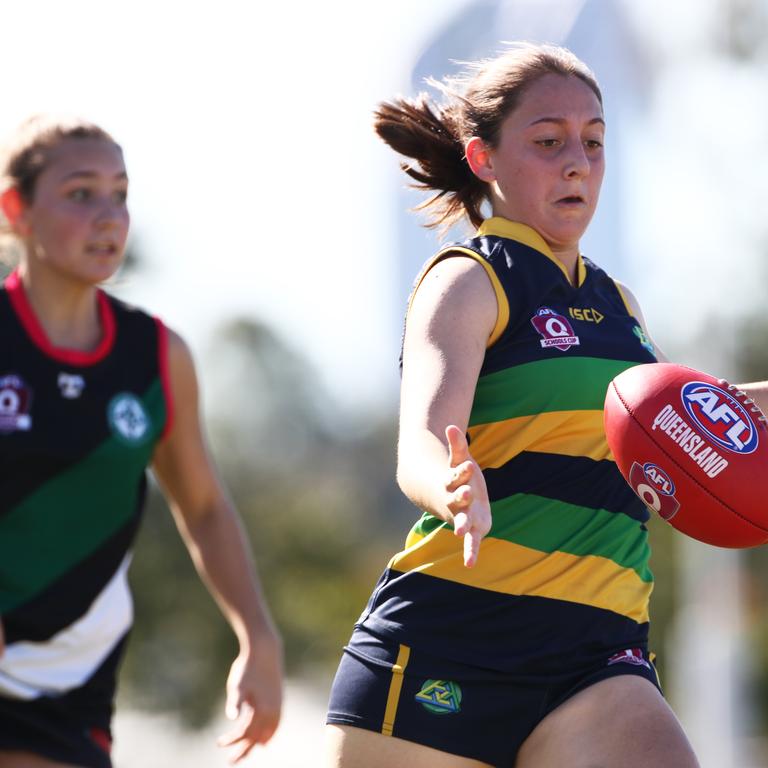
[509,74,603,127]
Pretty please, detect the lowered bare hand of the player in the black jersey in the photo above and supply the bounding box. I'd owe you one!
[218,634,283,763]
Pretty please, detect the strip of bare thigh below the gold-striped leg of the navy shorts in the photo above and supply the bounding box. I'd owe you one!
[326,725,489,768]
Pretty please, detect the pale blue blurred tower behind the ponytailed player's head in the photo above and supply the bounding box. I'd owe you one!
[396,0,651,306]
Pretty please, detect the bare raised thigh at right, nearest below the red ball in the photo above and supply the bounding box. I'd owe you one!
[515,675,699,768]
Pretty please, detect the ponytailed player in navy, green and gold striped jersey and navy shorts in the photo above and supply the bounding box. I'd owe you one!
[328,44,698,768]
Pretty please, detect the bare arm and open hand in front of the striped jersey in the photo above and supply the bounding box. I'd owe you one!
[397,256,497,567]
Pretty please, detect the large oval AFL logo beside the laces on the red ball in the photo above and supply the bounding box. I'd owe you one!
[680,381,758,454]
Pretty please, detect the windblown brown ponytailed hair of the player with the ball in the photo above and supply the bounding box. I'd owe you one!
[374,43,603,229]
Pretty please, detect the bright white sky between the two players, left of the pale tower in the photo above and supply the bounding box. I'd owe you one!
[0,0,464,416]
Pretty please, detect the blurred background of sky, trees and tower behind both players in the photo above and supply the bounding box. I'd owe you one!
[0,0,768,768]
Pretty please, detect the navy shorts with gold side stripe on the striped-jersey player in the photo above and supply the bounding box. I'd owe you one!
[326,627,661,768]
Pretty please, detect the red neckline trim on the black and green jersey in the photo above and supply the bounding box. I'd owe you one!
[4,270,115,365]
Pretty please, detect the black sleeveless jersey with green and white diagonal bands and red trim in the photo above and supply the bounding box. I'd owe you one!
[0,273,170,699]
